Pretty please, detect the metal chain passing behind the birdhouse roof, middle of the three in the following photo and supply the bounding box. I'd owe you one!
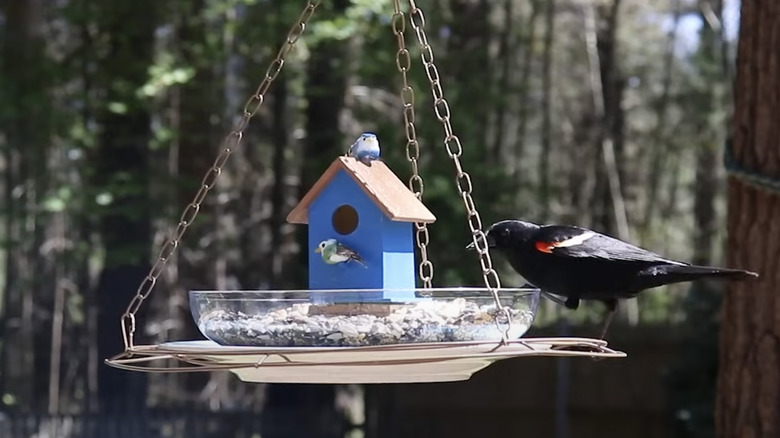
[392,0,433,289]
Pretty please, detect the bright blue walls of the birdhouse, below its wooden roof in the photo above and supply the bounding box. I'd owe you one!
[308,171,416,301]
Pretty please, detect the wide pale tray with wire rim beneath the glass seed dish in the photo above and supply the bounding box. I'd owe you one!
[105,338,626,384]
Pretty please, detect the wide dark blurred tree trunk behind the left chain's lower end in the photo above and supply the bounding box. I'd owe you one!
[93,1,156,410]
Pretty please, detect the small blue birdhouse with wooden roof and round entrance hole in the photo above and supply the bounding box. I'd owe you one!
[287,157,436,301]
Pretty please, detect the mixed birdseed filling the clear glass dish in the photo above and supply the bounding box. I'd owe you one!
[198,298,534,347]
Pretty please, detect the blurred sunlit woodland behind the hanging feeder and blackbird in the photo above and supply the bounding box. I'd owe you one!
[0,0,772,437]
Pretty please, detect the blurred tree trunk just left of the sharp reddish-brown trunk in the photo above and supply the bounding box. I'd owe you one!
[669,0,728,438]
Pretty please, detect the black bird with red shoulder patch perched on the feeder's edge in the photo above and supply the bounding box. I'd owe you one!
[467,220,758,338]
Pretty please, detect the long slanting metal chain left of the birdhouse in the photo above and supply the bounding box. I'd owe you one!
[121,0,321,351]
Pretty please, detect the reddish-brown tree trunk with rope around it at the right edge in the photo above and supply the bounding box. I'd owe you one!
[715,0,780,438]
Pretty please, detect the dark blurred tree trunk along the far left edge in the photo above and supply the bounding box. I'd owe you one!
[0,1,51,409]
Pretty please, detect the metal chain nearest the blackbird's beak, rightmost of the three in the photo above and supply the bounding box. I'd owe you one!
[402,0,512,342]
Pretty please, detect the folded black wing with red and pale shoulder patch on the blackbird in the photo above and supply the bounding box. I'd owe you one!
[534,226,685,265]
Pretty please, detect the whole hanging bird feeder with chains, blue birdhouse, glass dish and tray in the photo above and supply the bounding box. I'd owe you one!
[106,0,625,383]
